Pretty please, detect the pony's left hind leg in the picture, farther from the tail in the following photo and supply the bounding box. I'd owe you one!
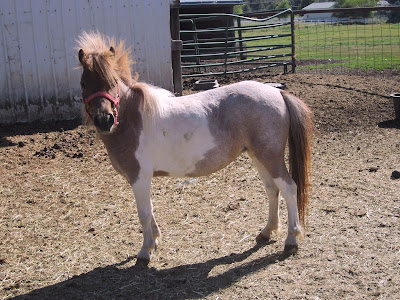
[250,155,280,243]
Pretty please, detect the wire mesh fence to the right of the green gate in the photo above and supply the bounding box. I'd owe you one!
[295,15,400,72]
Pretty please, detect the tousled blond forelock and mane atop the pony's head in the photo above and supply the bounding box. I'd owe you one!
[77,31,137,86]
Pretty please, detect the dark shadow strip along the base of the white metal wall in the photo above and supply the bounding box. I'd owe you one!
[0,118,82,147]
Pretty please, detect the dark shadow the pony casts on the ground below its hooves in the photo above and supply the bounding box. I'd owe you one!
[14,244,289,299]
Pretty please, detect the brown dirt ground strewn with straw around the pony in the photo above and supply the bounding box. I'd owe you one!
[0,72,400,299]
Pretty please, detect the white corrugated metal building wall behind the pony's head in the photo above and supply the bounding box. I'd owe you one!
[0,0,173,123]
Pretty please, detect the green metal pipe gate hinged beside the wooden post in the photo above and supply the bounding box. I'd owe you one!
[180,9,296,77]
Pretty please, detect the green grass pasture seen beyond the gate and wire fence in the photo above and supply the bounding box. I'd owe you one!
[243,23,400,70]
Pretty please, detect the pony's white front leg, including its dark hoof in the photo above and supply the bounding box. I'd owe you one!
[132,174,161,265]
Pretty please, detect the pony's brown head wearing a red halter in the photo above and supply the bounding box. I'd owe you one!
[79,47,120,133]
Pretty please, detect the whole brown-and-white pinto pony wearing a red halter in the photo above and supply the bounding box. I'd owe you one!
[78,32,312,265]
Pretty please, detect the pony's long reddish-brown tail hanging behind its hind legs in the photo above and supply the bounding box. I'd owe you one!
[281,91,313,225]
